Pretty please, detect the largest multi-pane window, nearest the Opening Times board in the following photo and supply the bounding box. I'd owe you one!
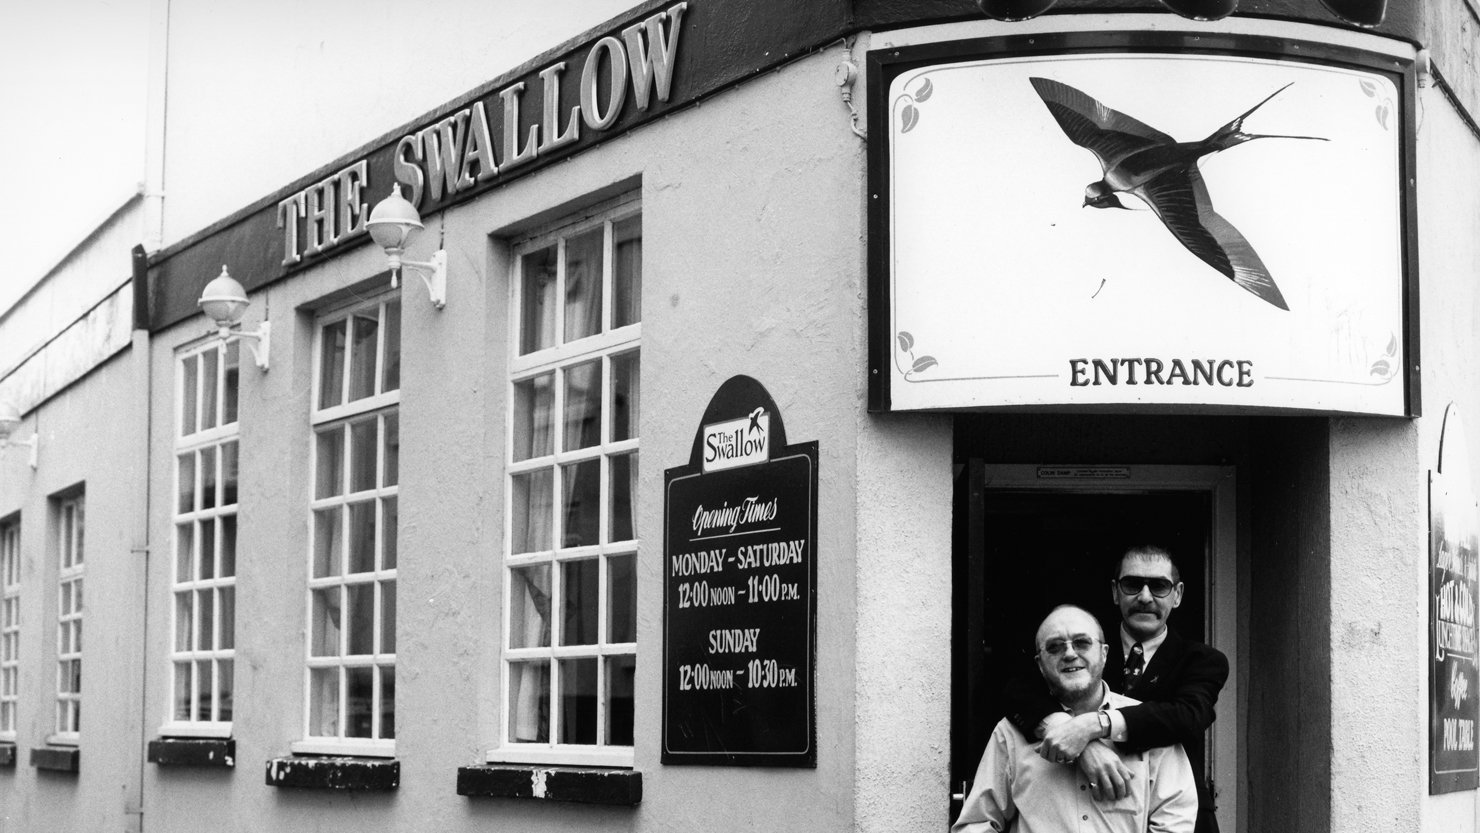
[490,201,642,765]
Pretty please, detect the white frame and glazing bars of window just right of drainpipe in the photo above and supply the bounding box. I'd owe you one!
[160,336,241,737]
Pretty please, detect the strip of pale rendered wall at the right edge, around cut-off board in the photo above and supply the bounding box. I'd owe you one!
[1410,75,1480,833]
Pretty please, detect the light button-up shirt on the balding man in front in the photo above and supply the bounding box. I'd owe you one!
[950,684,1197,833]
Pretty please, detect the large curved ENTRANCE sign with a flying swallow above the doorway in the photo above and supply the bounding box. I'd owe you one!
[869,33,1416,416]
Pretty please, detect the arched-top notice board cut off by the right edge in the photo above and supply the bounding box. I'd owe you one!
[1428,404,1480,795]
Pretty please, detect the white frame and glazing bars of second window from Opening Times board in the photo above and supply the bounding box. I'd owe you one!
[290,290,404,758]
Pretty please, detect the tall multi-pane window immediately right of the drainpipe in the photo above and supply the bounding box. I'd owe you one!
[163,339,240,735]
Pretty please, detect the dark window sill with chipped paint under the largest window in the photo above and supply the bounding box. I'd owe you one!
[457,763,642,806]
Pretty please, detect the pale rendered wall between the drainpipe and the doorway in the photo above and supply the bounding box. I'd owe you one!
[145,40,888,832]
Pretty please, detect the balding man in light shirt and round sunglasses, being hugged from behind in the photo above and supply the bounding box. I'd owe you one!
[952,605,1197,833]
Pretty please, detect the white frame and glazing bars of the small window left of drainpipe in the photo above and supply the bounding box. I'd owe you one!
[46,491,87,746]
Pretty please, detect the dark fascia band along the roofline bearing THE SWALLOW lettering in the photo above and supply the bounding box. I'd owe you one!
[136,0,1418,330]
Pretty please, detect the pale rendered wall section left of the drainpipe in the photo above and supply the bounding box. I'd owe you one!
[0,352,144,833]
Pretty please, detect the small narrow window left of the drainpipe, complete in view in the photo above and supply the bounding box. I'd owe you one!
[53,494,84,743]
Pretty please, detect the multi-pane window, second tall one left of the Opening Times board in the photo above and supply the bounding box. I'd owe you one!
[293,296,401,755]
